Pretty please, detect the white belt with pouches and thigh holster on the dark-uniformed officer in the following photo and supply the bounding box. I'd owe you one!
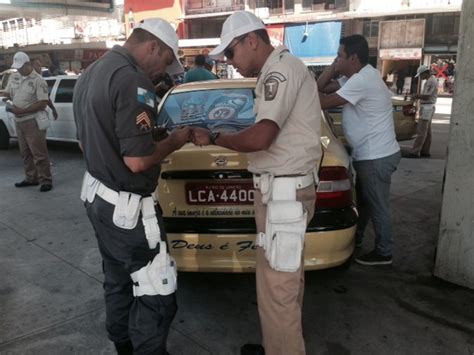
[81,171,177,297]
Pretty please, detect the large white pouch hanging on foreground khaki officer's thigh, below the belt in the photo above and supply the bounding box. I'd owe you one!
[263,201,308,272]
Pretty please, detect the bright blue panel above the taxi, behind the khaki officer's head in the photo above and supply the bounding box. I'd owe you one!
[285,22,342,65]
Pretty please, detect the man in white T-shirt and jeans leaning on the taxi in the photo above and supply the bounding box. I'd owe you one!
[318,35,400,265]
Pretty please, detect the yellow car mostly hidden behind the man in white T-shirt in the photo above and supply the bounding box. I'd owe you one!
[327,96,416,143]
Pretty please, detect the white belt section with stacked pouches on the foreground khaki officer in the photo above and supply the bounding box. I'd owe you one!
[257,174,314,272]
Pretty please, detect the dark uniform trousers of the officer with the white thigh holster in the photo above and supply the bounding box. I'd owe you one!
[86,196,177,355]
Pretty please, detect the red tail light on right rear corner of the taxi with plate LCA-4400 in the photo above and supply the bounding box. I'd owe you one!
[316,166,352,209]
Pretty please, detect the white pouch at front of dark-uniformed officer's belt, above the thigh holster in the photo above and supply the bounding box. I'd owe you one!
[112,191,142,229]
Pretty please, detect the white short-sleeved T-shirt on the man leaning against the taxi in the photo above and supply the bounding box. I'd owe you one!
[336,64,400,160]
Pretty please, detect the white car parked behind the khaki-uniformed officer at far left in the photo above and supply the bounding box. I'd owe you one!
[0,75,77,149]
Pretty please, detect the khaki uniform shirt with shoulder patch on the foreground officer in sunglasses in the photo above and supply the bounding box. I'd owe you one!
[248,46,321,176]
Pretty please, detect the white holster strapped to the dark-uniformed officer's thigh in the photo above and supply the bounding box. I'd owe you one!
[130,242,178,297]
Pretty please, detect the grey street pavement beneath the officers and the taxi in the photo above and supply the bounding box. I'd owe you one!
[0,99,474,355]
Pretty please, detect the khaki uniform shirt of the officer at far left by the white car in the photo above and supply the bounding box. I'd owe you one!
[6,70,48,122]
